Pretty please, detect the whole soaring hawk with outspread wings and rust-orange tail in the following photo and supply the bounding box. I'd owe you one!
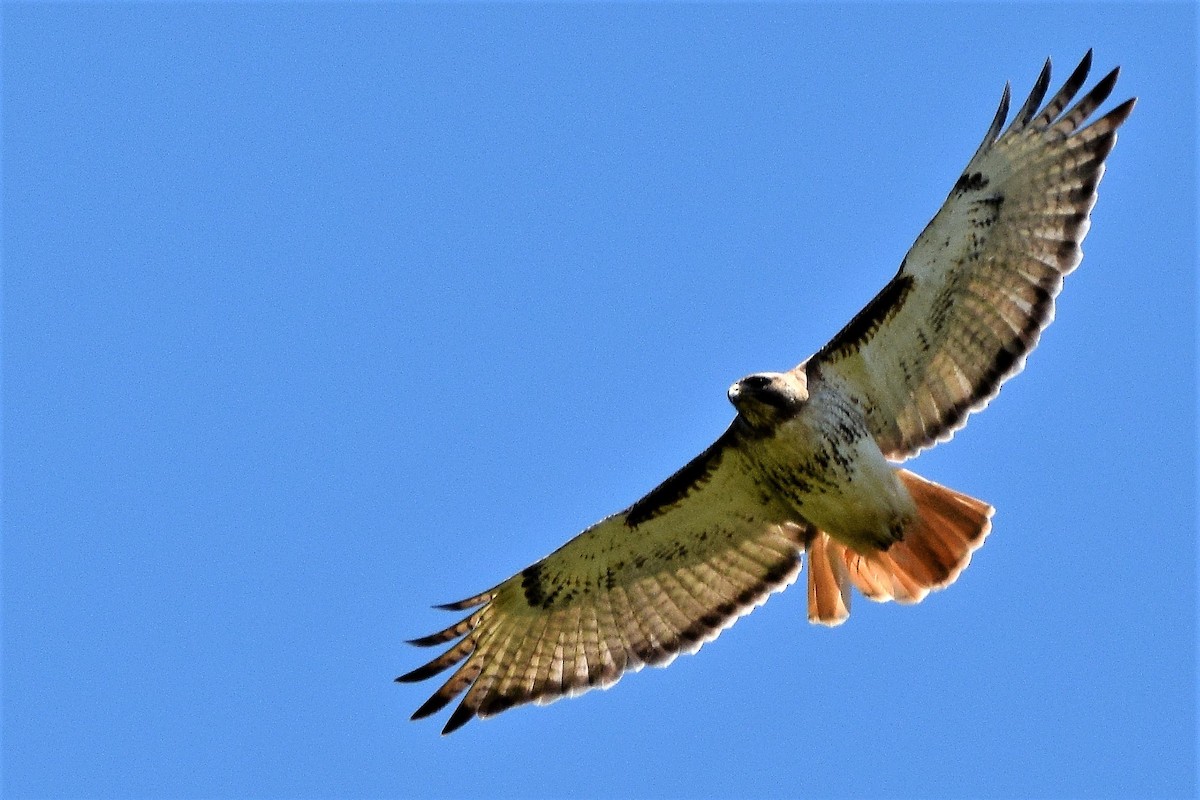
[396,50,1135,734]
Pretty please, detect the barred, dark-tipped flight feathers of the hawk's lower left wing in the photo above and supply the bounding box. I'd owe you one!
[396,527,802,734]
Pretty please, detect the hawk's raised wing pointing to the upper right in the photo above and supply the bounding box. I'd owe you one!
[797,50,1134,461]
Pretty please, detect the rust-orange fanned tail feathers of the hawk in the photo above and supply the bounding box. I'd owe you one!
[806,469,992,625]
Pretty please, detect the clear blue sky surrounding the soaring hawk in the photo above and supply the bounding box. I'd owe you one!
[2,4,1196,798]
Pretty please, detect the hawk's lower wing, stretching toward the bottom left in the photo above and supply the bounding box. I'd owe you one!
[396,422,808,733]
